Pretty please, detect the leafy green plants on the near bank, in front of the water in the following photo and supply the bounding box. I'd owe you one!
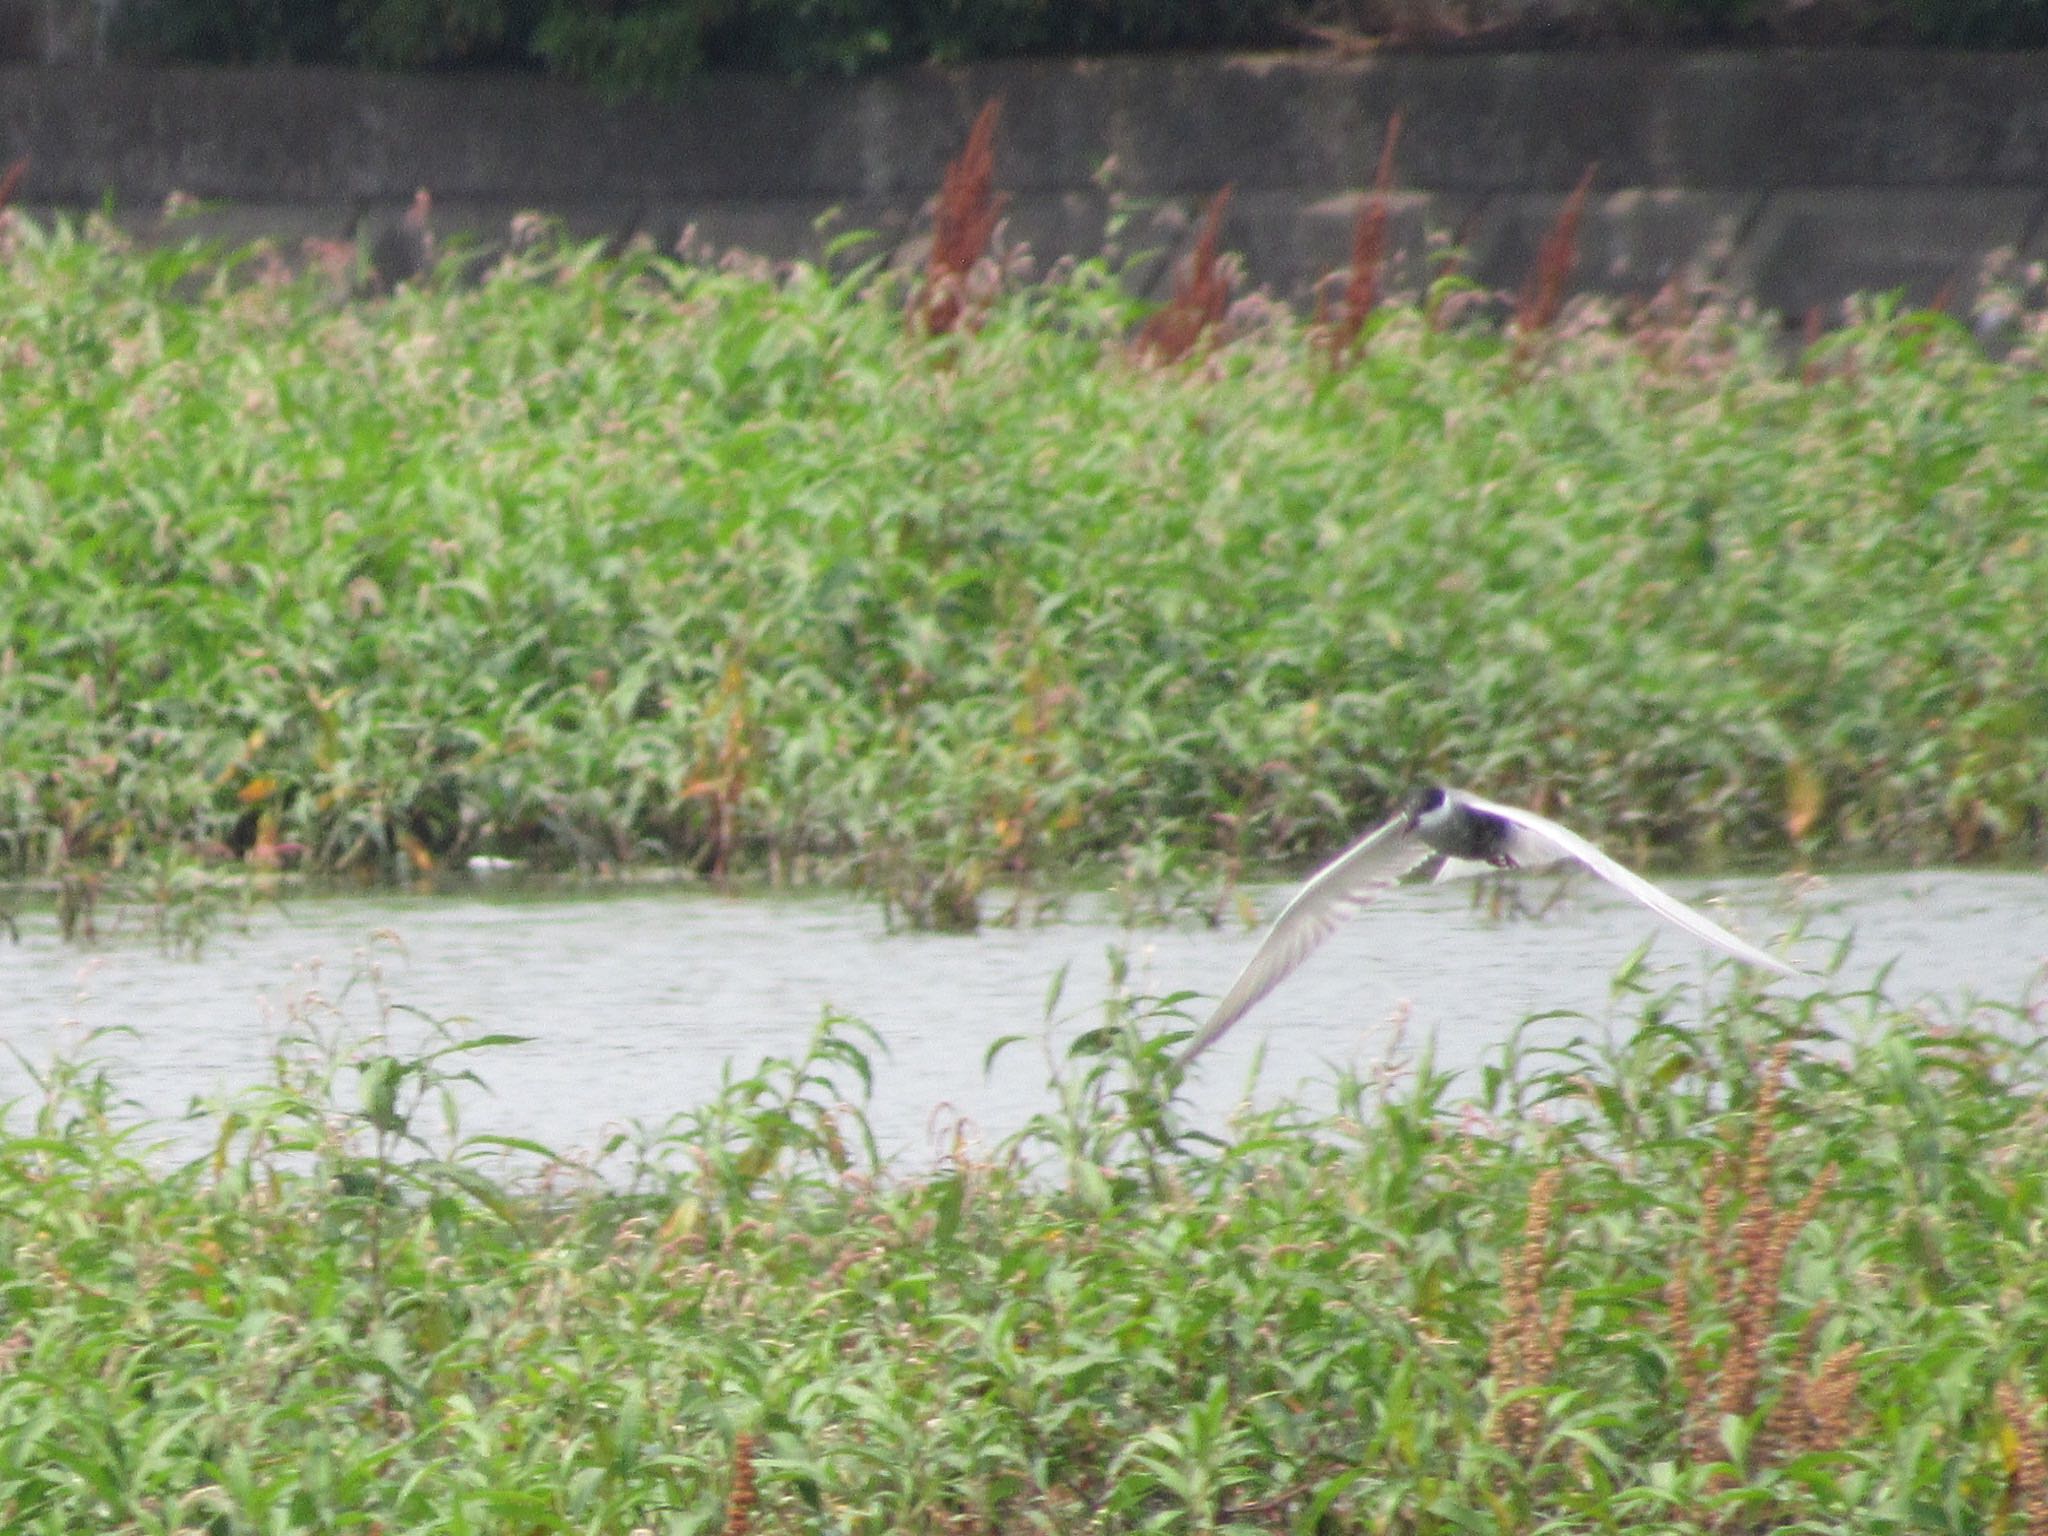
[0,978,2048,1536]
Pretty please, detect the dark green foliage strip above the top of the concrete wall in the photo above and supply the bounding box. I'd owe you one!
[106,0,2048,90]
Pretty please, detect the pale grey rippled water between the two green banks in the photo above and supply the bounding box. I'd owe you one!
[0,872,2048,1159]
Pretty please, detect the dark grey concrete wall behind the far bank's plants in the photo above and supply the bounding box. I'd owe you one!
[0,51,2048,315]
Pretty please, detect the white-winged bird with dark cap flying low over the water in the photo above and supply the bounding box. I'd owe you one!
[1180,788,1806,1067]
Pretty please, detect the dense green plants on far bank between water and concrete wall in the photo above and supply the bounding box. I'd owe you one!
[0,223,2048,920]
